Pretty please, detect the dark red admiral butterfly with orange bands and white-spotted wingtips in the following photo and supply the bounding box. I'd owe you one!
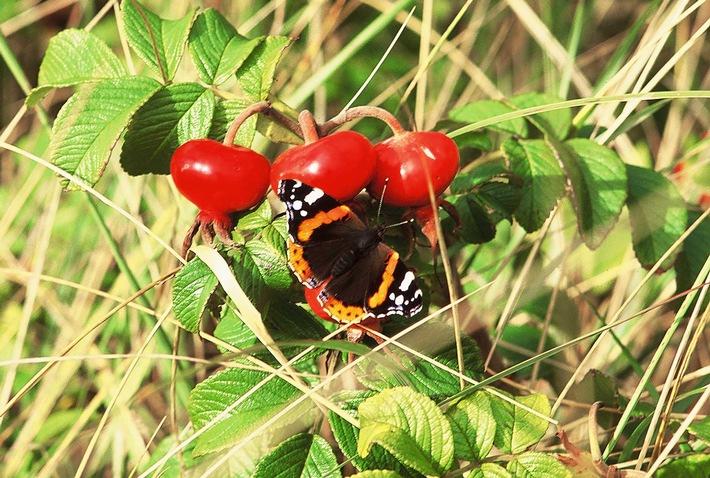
[279,179,422,334]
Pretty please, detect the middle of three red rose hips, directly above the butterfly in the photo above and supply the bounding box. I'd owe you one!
[271,131,375,202]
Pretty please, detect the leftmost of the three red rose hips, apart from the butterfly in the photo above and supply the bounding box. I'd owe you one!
[170,139,270,222]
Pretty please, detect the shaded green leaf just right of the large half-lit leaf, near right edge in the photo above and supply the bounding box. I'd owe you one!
[626,165,688,271]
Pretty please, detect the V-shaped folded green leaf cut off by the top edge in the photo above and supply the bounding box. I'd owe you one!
[121,0,197,82]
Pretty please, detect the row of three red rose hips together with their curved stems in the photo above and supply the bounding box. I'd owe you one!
[170,102,459,255]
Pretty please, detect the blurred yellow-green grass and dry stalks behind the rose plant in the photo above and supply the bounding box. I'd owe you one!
[0,0,710,477]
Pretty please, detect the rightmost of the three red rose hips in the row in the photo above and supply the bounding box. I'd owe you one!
[368,131,459,207]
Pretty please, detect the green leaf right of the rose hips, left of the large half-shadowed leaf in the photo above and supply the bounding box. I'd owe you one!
[502,139,565,232]
